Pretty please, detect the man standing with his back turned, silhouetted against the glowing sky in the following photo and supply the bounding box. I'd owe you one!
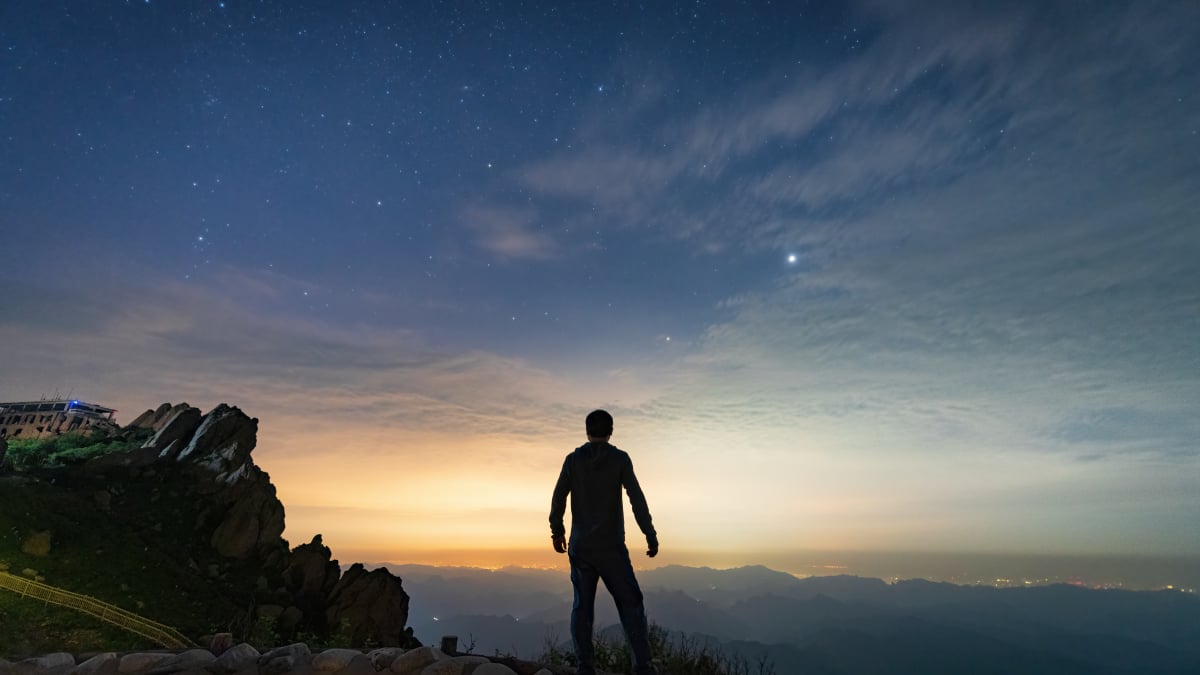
[550,410,659,675]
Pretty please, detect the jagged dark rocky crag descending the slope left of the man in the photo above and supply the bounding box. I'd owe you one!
[77,404,419,647]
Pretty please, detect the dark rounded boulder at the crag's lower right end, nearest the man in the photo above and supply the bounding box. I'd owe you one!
[325,562,412,646]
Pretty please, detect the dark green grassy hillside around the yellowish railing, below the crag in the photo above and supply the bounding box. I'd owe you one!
[0,461,244,655]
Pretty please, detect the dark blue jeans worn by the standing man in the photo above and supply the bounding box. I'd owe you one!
[570,546,654,675]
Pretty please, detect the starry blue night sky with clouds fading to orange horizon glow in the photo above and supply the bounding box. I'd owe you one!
[0,0,1200,565]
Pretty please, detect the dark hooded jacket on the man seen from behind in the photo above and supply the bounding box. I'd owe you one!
[550,442,658,551]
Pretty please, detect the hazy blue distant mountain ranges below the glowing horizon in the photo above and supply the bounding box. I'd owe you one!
[374,557,1200,675]
